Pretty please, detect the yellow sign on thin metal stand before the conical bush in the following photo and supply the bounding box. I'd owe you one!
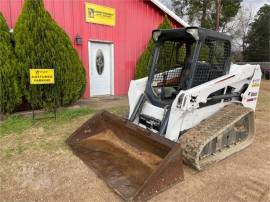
[30,69,54,84]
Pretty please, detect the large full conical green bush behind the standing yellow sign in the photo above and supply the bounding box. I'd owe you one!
[14,0,86,108]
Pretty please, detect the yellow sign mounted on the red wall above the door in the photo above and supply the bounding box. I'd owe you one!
[85,2,115,26]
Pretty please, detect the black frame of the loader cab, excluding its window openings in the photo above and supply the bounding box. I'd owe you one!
[145,27,231,107]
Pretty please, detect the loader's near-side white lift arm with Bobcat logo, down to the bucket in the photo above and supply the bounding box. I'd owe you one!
[165,65,261,141]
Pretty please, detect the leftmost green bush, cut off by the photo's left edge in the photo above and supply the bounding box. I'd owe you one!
[0,12,21,112]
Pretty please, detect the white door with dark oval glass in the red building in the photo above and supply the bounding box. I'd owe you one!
[88,42,113,96]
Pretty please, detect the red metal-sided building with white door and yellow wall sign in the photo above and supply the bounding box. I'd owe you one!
[0,0,187,97]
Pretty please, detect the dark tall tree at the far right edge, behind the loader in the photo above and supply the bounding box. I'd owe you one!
[244,4,270,62]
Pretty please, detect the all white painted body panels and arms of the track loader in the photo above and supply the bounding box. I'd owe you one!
[128,64,261,141]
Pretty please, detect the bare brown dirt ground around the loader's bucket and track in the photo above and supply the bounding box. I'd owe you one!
[0,81,270,202]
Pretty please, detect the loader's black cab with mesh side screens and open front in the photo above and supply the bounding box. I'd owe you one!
[145,27,231,107]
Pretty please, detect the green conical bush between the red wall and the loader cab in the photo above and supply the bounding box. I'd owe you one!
[135,16,172,79]
